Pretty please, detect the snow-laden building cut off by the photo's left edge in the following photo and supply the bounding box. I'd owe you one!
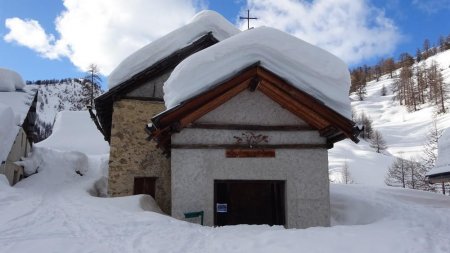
[0,69,37,185]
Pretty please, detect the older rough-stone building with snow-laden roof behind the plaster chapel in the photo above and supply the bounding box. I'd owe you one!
[95,11,239,213]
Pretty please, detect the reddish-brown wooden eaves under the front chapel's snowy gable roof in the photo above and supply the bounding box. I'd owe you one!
[146,63,359,154]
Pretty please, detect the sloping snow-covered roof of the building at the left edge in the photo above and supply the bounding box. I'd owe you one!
[0,87,36,162]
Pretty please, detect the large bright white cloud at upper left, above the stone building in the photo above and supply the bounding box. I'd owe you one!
[4,0,202,75]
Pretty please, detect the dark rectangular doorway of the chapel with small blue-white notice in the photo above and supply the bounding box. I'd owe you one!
[214,180,285,226]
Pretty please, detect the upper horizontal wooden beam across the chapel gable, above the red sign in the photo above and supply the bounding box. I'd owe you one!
[186,123,316,131]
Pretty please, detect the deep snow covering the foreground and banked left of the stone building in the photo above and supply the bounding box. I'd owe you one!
[0,108,450,253]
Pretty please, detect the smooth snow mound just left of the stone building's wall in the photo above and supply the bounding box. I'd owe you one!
[36,111,109,155]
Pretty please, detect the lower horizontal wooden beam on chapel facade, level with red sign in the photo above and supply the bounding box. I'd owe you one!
[171,144,327,149]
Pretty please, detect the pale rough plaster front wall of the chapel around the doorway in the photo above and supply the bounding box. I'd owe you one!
[171,91,330,228]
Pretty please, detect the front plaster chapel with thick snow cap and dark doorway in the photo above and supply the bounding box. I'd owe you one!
[147,27,359,228]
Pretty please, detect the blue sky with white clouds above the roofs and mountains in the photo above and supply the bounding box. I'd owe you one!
[0,0,450,87]
